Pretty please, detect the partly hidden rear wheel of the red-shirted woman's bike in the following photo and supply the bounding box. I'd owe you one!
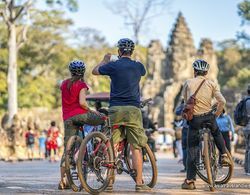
[65,135,82,192]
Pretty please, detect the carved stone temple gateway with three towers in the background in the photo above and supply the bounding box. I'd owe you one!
[142,13,218,128]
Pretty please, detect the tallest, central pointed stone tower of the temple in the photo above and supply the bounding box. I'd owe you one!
[164,13,196,127]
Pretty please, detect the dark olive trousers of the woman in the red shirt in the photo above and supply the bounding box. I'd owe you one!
[61,111,105,167]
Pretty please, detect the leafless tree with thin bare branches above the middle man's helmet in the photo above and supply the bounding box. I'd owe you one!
[107,0,170,44]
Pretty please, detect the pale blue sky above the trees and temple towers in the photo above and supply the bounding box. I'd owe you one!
[59,0,246,47]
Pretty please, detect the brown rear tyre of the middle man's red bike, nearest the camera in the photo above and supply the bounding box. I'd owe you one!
[77,132,114,194]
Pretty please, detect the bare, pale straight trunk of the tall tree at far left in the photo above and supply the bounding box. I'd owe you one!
[7,24,18,122]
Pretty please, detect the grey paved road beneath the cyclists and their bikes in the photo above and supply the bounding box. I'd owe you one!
[0,154,250,195]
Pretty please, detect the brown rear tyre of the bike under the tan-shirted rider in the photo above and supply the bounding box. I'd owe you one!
[203,132,214,191]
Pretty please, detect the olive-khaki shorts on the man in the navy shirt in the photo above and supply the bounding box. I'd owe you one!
[109,106,148,149]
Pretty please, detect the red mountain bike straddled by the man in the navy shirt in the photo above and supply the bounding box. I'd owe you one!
[77,99,157,194]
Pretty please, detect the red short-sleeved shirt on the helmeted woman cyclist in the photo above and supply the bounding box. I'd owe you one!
[61,79,89,120]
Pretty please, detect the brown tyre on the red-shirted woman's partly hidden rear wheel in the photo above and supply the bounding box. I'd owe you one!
[65,135,82,192]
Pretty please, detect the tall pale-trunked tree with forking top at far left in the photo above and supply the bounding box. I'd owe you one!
[0,0,77,122]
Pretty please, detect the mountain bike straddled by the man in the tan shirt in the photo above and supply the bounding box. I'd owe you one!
[196,123,234,191]
